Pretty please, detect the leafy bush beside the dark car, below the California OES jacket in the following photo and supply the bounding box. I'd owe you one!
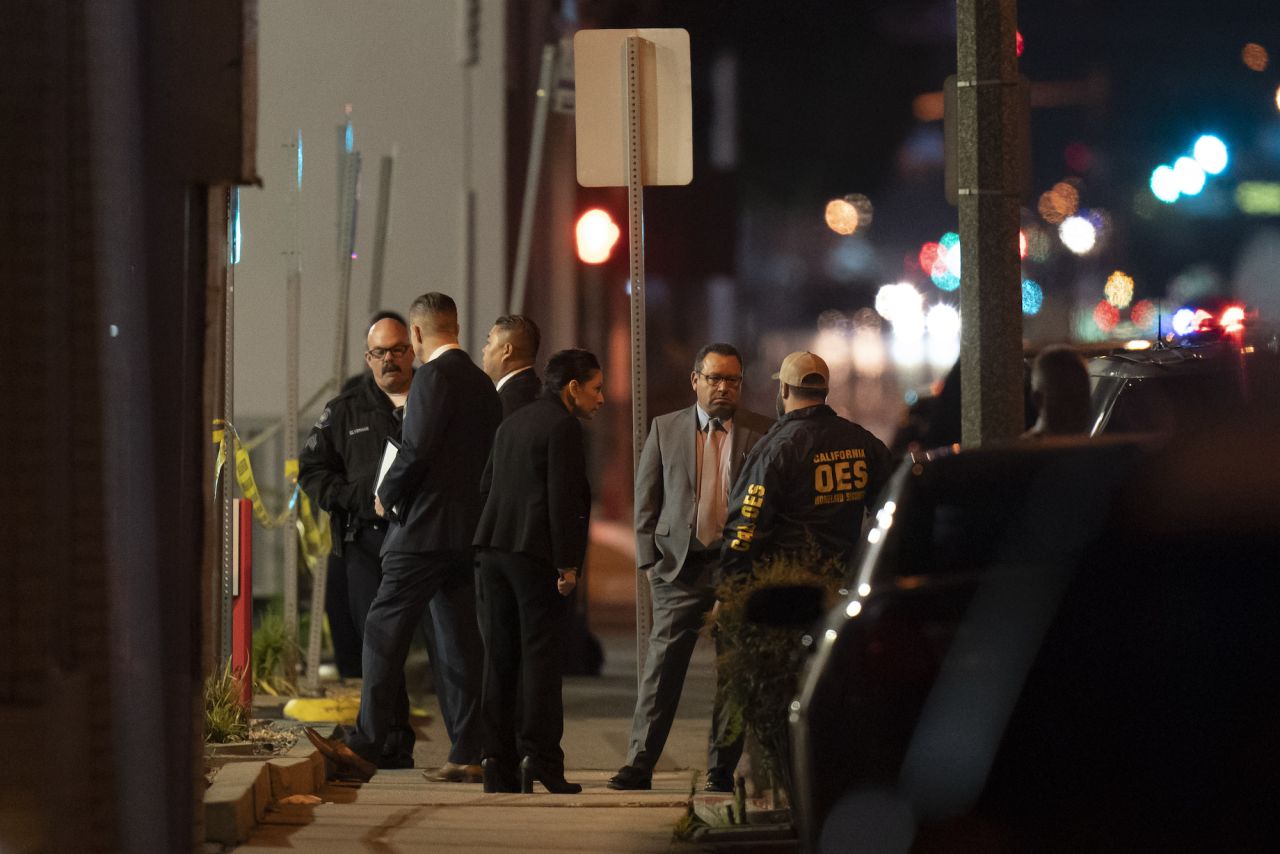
[716,547,844,802]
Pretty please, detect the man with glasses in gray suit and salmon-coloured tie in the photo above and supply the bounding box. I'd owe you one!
[608,343,771,791]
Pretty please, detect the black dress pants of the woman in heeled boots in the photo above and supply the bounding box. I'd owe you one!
[476,549,566,776]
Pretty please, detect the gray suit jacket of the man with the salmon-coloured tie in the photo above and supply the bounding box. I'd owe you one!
[635,406,773,581]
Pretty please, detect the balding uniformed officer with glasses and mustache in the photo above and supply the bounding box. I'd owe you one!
[298,316,413,676]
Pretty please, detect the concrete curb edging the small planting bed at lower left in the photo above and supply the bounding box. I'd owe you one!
[205,740,325,845]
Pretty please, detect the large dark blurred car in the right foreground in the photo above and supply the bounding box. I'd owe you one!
[765,430,1280,854]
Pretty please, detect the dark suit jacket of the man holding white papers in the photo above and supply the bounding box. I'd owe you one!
[378,350,502,553]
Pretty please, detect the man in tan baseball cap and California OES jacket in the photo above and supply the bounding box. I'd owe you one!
[721,351,890,574]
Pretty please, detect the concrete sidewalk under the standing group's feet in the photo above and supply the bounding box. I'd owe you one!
[215,625,785,854]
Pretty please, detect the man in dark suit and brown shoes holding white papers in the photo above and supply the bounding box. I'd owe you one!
[307,293,502,782]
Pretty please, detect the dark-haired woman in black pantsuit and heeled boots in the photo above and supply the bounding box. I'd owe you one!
[474,350,604,794]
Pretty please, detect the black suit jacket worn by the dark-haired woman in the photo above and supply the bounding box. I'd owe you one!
[474,393,591,568]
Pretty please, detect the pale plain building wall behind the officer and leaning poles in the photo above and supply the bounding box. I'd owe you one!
[234,0,507,426]
